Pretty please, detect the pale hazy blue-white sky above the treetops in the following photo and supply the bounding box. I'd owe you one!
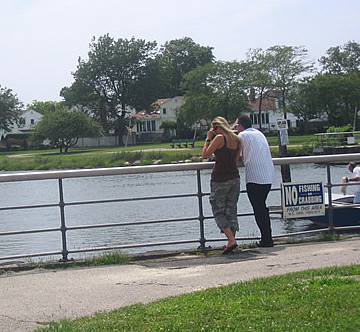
[0,0,360,105]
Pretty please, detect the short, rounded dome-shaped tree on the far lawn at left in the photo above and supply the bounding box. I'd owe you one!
[34,111,102,153]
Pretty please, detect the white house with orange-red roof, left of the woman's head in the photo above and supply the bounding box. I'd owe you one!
[135,96,184,142]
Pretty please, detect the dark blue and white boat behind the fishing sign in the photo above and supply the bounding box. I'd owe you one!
[310,194,360,227]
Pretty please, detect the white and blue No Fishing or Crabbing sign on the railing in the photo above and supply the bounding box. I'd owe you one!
[281,182,325,219]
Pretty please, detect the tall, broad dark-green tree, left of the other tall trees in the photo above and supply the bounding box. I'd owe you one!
[61,35,158,142]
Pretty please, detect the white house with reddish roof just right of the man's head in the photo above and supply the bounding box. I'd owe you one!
[243,92,299,130]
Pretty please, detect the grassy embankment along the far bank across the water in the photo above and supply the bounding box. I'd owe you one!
[0,135,314,171]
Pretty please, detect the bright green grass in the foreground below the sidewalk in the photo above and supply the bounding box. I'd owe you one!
[37,265,360,332]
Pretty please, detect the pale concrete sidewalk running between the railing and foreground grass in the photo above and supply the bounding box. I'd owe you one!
[0,237,360,331]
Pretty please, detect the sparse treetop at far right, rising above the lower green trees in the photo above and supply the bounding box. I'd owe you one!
[319,41,360,75]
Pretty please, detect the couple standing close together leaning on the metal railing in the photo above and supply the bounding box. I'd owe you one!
[202,115,275,254]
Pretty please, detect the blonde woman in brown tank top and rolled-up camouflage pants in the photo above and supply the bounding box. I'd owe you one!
[202,116,241,254]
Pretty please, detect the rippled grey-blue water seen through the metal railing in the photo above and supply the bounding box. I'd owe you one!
[0,164,353,258]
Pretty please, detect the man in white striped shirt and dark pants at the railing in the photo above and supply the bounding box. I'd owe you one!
[237,115,275,247]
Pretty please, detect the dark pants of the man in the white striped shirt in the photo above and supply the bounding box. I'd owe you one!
[246,183,273,245]
